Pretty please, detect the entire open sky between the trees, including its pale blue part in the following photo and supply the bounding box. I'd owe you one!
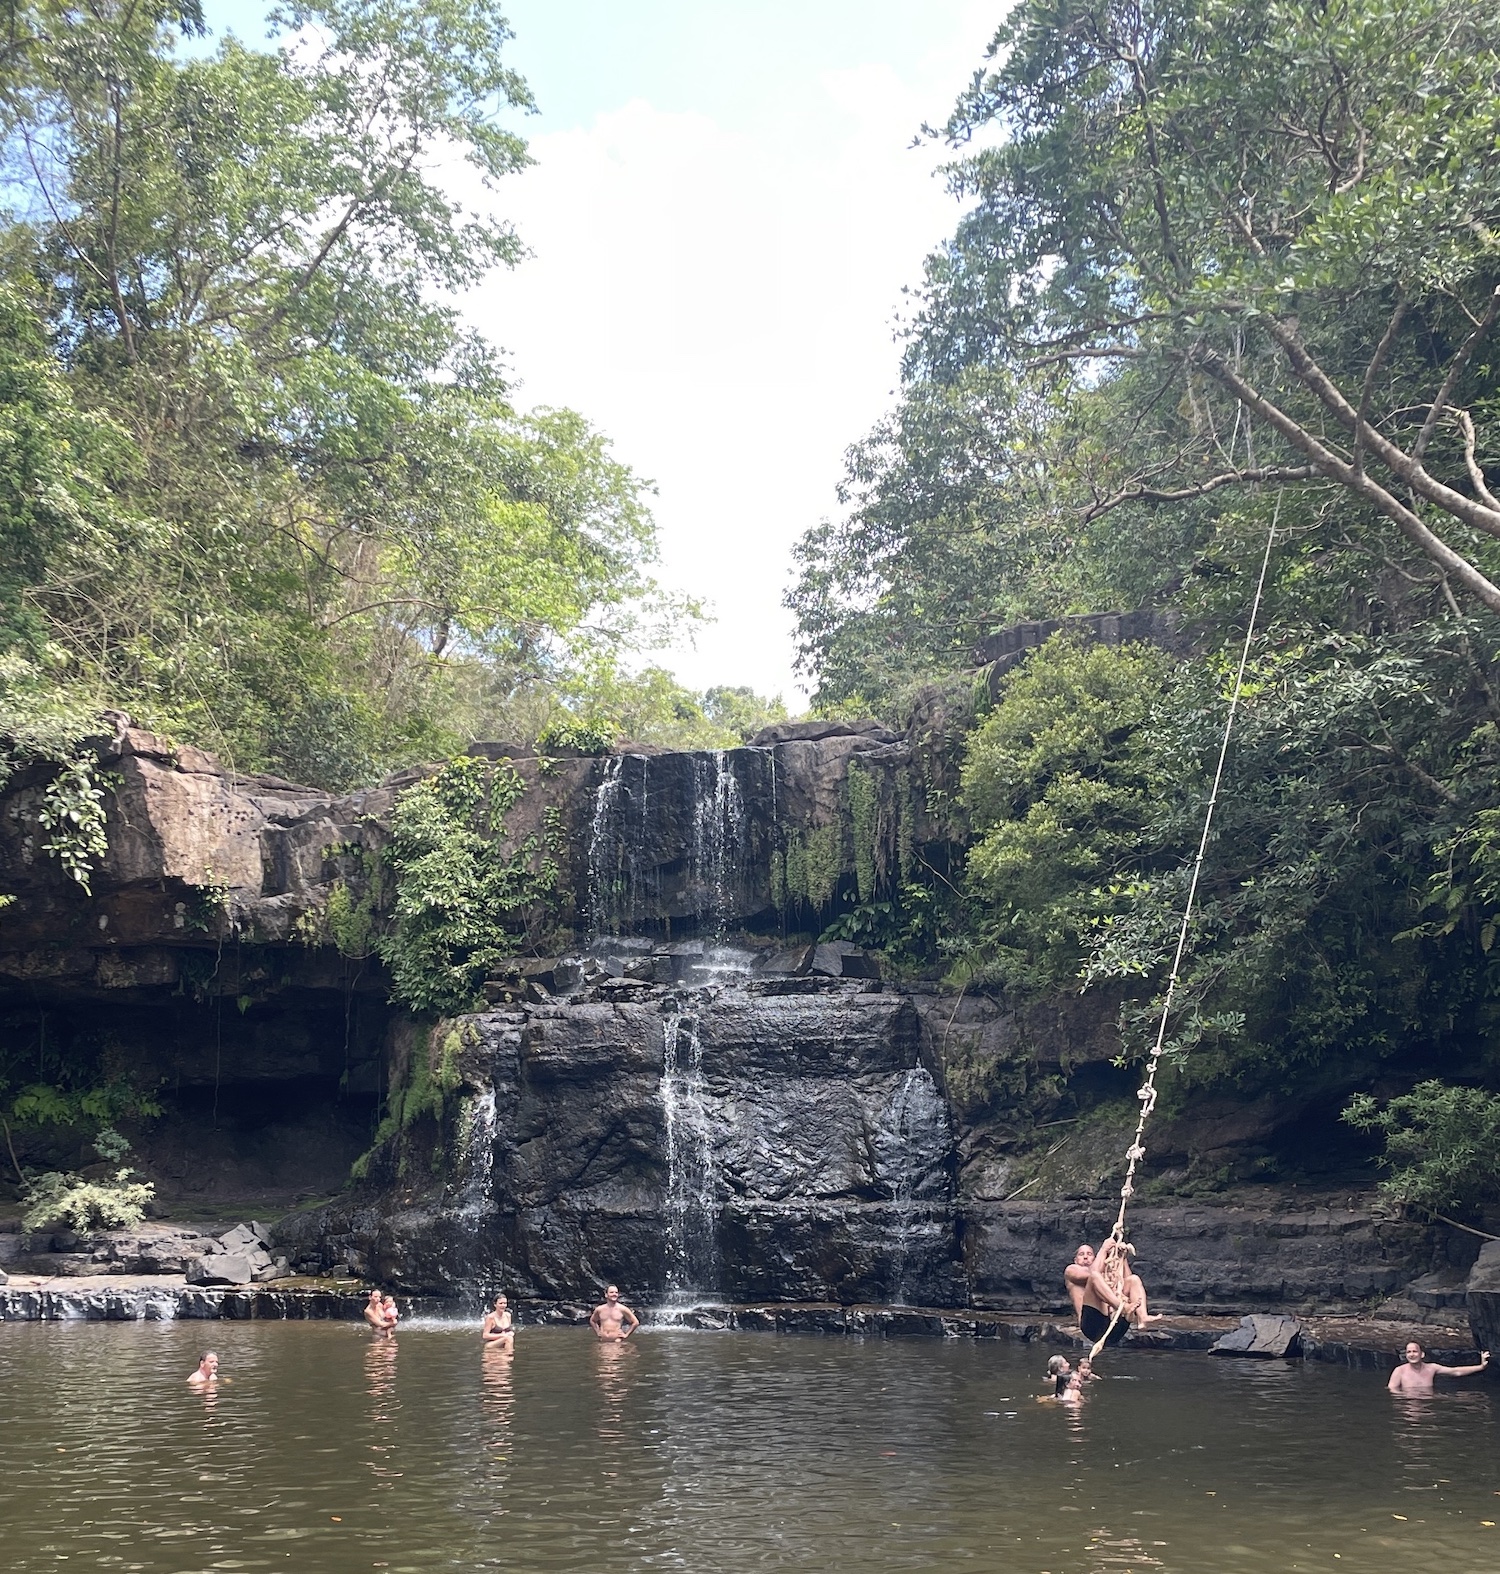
[208,0,1006,708]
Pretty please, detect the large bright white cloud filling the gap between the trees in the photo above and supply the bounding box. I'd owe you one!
[466,6,993,702]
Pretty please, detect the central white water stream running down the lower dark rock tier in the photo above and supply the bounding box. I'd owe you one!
[661,1012,719,1302]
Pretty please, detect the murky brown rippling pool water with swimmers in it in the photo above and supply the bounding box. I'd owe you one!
[0,1322,1500,1574]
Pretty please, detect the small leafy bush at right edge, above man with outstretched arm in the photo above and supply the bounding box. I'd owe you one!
[1344,1081,1500,1214]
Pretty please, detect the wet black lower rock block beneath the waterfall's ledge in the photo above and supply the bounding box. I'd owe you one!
[282,979,965,1305]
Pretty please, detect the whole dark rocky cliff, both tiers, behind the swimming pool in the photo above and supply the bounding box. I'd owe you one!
[0,714,1472,1311]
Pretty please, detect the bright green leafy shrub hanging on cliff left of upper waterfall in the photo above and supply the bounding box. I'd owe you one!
[378,757,557,1012]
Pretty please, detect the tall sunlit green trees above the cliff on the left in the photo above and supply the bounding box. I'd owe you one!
[0,0,694,787]
